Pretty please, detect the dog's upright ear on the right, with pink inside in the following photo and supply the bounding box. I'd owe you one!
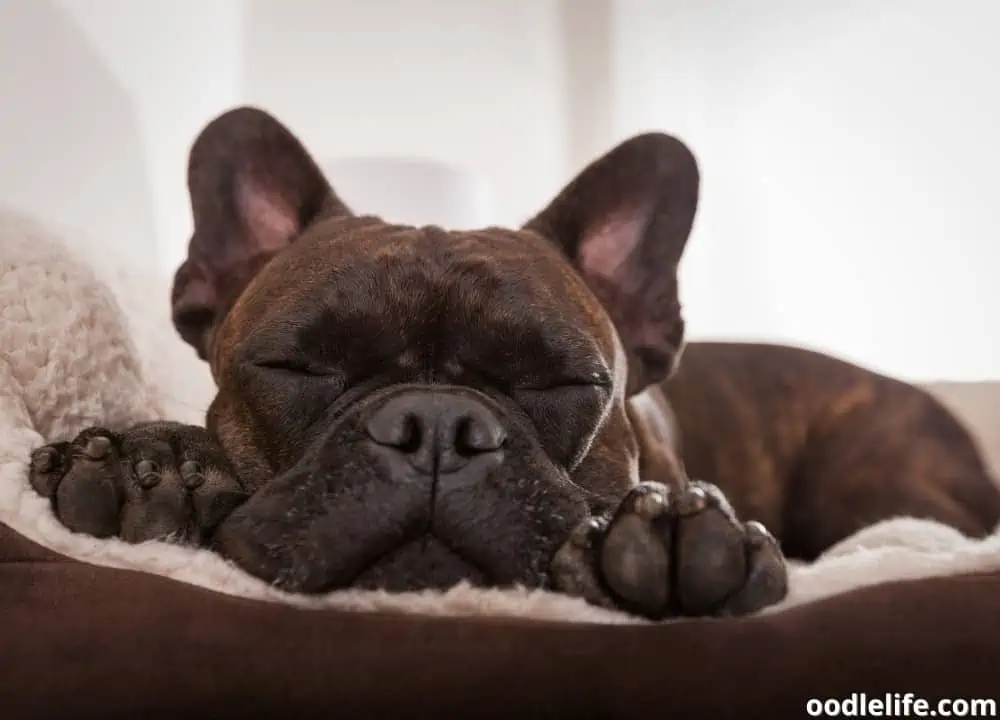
[525,133,699,394]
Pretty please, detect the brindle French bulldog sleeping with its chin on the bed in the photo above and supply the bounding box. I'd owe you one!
[25,108,1000,618]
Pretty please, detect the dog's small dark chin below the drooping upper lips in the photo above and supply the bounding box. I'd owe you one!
[352,535,490,592]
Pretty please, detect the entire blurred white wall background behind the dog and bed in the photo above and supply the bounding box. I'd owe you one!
[0,0,1000,380]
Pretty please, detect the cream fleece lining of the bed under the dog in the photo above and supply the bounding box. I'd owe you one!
[0,213,1000,623]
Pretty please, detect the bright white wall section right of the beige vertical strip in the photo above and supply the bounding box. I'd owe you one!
[615,0,1000,378]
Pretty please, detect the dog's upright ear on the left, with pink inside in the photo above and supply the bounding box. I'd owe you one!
[171,107,350,359]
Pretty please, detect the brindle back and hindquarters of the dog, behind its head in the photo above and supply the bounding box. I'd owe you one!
[664,342,1000,559]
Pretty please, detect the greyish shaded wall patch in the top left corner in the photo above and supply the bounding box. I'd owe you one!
[0,0,156,270]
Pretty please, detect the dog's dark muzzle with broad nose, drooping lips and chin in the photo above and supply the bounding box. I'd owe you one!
[211,385,589,592]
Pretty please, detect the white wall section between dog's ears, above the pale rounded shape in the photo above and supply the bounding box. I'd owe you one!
[244,0,567,229]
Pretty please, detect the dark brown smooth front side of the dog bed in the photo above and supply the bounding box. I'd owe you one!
[0,527,1000,720]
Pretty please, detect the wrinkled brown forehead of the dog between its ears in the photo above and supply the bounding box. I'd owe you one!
[233,216,610,330]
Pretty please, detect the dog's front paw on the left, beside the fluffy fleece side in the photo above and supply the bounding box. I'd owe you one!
[29,422,246,544]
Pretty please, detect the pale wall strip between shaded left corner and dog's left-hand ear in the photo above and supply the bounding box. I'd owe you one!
[59,0,243,272]
